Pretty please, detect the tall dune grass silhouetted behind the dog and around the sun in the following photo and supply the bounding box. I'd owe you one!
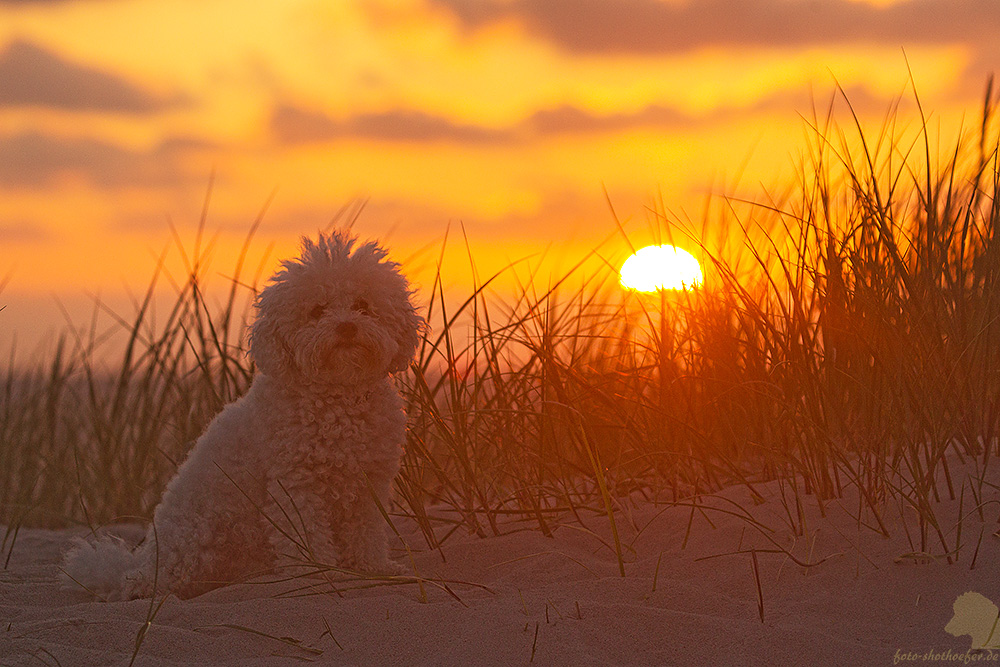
[0,82,1000,576]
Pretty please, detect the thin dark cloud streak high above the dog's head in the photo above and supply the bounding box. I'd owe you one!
[271,106,505,143]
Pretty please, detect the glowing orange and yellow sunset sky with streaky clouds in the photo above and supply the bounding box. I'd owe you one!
[0,0,1000,355]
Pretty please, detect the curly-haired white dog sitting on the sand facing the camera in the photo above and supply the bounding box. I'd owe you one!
[64,233,422,600]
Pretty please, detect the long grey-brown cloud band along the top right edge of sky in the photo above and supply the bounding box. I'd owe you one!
[430,0,1000,54]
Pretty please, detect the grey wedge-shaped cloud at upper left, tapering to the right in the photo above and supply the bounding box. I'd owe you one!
[0,41,181,114]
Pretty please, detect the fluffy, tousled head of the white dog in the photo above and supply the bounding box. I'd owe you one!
[250,232,423,388]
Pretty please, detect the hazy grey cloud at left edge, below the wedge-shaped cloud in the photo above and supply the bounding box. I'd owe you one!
[0,132,211,188]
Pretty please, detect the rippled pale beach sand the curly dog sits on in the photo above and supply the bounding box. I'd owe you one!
[0,468,1000,667]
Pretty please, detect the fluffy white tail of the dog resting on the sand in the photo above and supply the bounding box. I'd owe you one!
[60,535,146,600]
